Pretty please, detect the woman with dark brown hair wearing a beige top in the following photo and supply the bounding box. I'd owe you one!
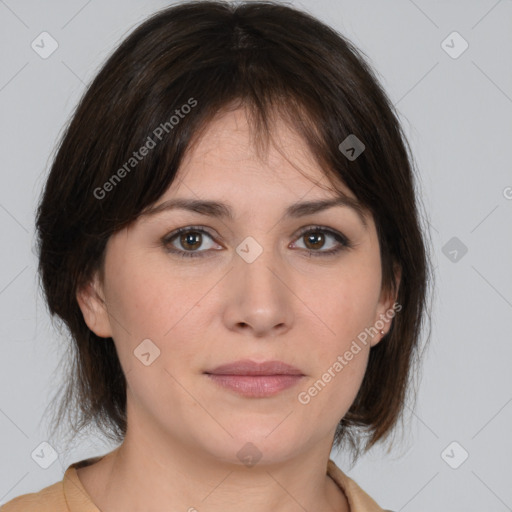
[2,1,429,512]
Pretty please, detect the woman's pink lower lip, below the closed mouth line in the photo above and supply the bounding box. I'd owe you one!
[207,373,303,398]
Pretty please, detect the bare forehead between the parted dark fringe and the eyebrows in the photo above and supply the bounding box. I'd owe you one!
[171,109,355,199]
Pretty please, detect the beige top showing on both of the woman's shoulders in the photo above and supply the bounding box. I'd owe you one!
[0,456,391,512]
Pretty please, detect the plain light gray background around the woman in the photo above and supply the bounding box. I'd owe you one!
[0,0,512,512]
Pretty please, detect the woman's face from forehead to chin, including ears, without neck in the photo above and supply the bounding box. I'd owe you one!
[79,110,393,464]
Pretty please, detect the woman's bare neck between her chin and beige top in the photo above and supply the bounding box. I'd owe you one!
[78,432,349,512]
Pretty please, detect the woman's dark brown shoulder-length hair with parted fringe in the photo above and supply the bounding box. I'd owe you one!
[36,1,430,457]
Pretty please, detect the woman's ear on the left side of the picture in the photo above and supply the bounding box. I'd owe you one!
[76,272,112,338]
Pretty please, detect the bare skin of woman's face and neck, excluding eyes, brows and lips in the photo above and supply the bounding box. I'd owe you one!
[77,106,400,512]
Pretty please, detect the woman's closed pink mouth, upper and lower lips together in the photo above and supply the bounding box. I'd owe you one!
[204,360,305,398]
